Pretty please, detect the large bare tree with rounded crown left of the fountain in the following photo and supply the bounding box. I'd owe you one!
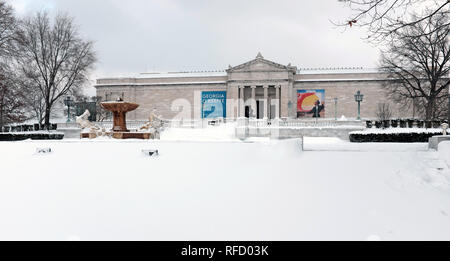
[17,13,96,128]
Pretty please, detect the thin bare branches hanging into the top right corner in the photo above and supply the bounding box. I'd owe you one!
[336,0,450,42]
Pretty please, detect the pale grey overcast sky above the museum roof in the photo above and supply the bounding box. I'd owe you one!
[7,0,379,77]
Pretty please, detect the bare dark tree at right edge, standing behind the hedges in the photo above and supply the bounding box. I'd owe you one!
[380,9,450,120]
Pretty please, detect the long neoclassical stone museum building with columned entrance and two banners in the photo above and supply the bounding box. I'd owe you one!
[95,53,412,120]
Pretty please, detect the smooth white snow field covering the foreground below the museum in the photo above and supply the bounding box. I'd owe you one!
[0,130,450,240]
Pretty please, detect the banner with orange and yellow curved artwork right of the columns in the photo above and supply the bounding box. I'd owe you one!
[297,89,325,118]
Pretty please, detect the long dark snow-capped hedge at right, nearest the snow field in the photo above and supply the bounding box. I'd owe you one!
[350,132,439,142]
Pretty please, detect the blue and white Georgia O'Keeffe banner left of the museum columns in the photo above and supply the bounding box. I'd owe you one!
[202,91,227,119]
